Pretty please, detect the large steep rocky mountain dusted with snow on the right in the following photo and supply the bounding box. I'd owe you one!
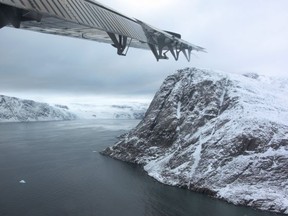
[103,68,288,214]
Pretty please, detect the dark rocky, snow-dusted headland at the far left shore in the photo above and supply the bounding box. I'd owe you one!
[0,95,77,122]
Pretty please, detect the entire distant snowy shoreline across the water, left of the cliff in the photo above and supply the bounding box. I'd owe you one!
[0,95,148,122]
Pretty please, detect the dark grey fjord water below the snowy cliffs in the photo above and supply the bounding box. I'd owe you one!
[0,120,282,216]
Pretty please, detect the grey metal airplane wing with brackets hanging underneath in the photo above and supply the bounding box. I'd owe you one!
[0,0,205,61]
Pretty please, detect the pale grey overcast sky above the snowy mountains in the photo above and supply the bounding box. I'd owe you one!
[0,0,288,103]
